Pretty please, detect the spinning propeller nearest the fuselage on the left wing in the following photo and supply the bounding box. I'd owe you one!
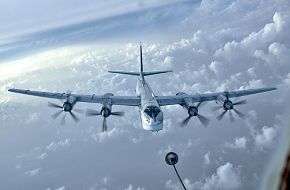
[86,107,124,132]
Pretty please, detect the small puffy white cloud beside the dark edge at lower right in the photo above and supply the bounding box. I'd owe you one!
[255,126,277,149]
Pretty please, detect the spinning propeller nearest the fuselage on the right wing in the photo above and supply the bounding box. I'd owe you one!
[181,102,210,127]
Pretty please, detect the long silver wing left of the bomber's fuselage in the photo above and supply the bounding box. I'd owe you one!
[8,88,140,106]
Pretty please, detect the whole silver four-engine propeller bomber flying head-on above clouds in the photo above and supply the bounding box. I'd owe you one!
[8,44,276,132]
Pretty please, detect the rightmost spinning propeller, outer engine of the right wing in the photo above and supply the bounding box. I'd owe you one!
[212,96,247,122]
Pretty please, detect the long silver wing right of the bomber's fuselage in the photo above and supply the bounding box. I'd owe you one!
[156,88,277,106]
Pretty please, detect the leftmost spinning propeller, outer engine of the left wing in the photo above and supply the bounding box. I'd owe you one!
[48,101,83,125]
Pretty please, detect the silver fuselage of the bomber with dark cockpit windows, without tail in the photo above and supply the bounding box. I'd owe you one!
[136,77,163,132]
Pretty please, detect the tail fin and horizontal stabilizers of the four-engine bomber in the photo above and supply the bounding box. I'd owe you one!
[108,42,172,80]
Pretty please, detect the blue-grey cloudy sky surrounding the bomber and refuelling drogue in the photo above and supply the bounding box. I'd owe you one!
[0,0,290,190]
